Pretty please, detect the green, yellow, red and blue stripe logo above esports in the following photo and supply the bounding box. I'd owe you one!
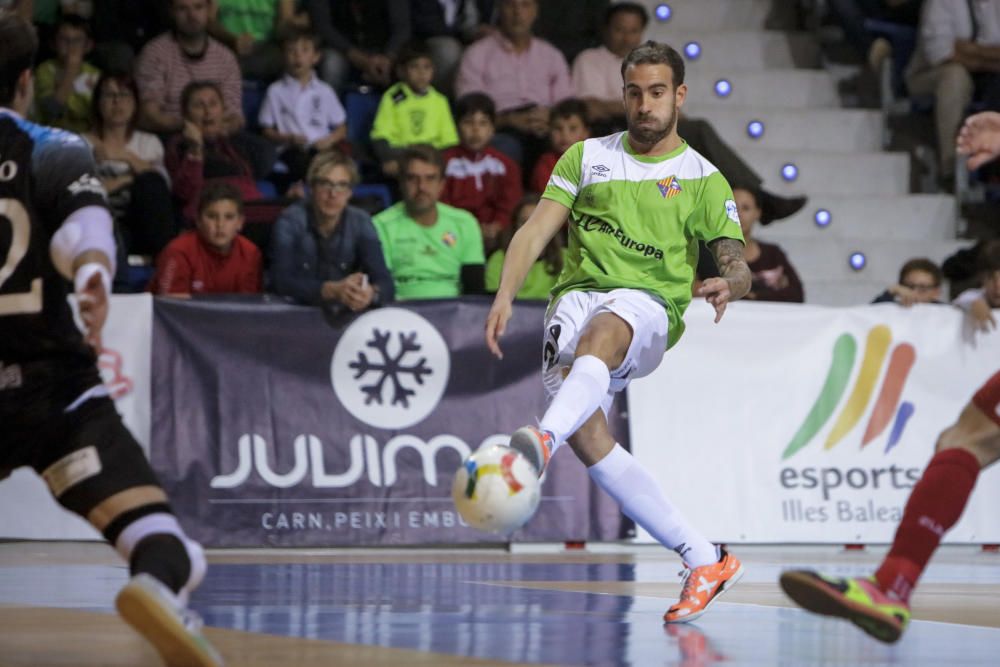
[781,325,917,459]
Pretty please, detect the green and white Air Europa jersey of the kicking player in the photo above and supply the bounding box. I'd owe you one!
[542,132,743,348]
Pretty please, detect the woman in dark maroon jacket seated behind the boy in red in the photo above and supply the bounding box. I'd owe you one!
[166,79,262,223]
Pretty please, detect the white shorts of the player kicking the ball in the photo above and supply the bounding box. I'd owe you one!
[542,289,669,415]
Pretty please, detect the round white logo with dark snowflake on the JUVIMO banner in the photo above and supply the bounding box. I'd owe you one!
[330,308,451,429]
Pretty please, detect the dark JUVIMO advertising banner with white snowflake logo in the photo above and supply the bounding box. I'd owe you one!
[152,299,627,547]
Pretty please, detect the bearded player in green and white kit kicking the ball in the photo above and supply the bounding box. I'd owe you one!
[486,41,750,623]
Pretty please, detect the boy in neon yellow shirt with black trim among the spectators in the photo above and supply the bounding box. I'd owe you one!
[371,42,458,176]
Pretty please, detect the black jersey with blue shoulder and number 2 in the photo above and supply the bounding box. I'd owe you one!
[0,110,106,364]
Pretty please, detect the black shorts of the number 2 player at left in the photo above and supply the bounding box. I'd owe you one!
[0,361,160,517]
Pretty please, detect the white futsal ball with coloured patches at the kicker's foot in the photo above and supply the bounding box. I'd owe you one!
[451,445,541,533]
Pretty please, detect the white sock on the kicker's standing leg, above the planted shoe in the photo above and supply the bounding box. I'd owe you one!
[587,443,719,568]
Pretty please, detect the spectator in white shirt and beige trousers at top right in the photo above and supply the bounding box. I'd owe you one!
[906,0,1000,189]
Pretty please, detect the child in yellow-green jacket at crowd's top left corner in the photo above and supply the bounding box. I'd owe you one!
[35,14,101,133]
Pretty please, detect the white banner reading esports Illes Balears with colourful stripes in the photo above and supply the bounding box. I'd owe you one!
[628,302,1000,543]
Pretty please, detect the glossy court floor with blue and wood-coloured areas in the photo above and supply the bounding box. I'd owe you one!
[0,542,1000,667]
